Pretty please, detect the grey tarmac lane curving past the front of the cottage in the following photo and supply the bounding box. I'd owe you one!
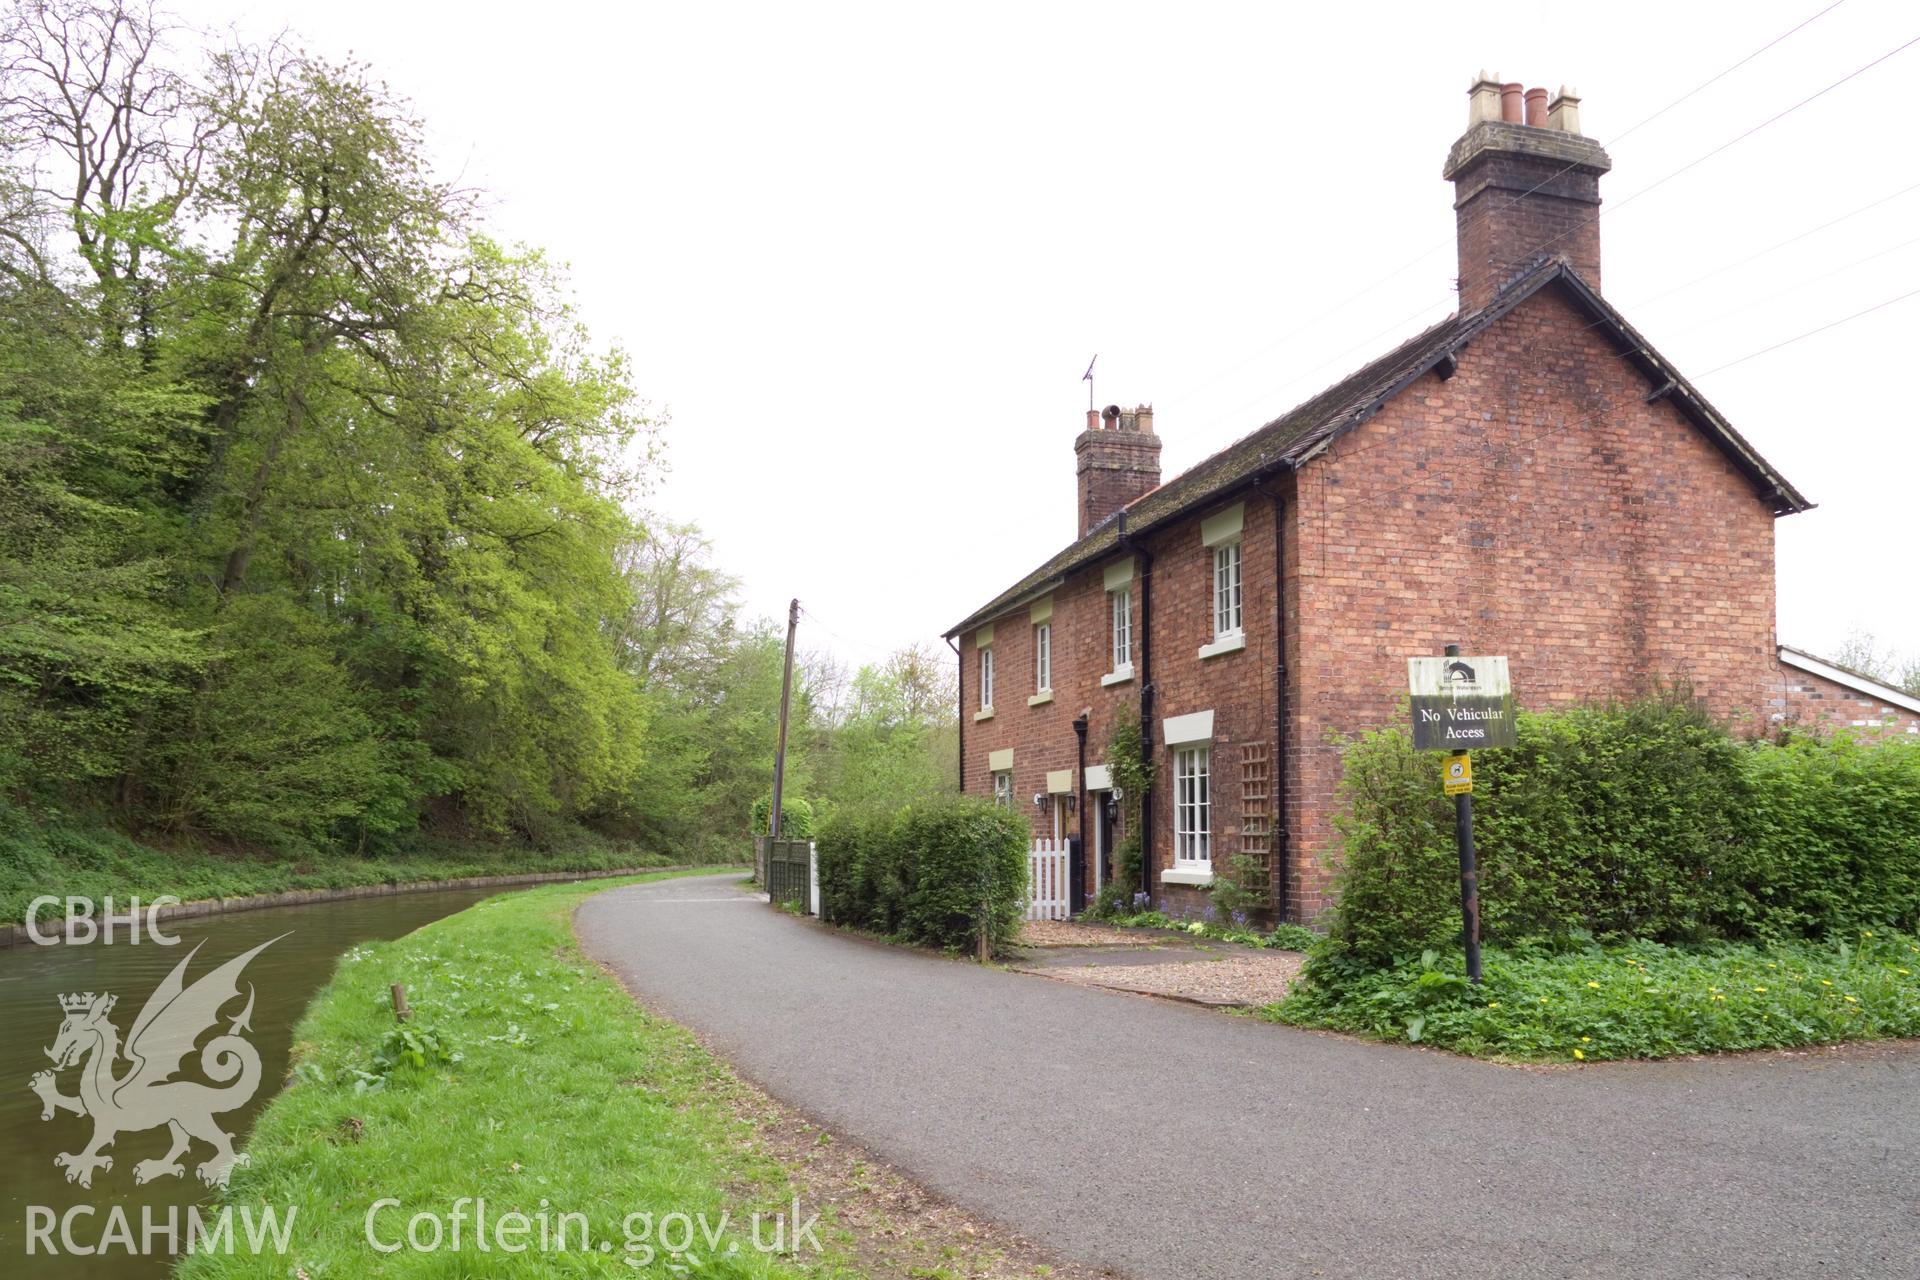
[576,879,1920,1280]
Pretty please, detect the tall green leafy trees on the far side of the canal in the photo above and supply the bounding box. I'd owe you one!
[0,0,954,858]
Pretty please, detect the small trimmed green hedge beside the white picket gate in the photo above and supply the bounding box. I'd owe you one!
[816,798,1029,952]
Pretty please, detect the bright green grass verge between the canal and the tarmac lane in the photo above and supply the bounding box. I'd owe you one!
[177,877,841,1280]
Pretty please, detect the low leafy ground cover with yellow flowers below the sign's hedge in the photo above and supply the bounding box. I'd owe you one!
[1261,931,1920,1061]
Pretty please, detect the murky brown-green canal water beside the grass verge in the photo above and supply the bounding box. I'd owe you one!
[0,889,501,1280]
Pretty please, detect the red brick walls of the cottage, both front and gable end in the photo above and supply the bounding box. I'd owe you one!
[960,290,1789,919]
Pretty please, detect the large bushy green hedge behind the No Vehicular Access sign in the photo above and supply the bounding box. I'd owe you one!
[1331,699,1920,965]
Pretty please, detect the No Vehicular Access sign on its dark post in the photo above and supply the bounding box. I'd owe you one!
[1407,645,1519,983]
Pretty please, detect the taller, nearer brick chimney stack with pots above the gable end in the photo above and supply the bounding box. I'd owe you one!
[1442,71,1613,311]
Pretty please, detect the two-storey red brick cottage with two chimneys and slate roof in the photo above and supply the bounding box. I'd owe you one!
[947,79,1920,919]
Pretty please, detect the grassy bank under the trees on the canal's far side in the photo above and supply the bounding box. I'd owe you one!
[0,804,701,921]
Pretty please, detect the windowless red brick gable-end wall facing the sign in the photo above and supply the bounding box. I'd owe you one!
[1288,290,1776,917]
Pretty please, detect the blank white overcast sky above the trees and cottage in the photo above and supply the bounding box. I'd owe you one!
[184,0,1920,675]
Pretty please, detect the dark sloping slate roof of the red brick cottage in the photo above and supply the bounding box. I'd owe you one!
[947,257,1812,637]
